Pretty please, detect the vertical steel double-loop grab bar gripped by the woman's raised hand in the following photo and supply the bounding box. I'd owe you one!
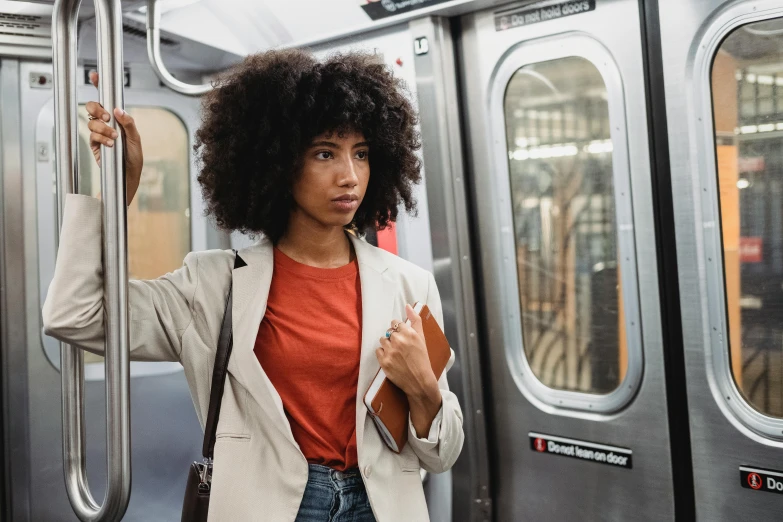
[52,0,131,522]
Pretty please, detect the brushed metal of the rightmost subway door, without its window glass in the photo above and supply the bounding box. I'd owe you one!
[659,0,783,521]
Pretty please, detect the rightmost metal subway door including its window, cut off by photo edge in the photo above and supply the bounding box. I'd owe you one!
[658,0,783,521]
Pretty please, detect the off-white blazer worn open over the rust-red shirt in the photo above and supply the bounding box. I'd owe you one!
[43,195,464,522]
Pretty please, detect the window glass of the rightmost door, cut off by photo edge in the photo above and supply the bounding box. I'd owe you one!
[712,20,783,417]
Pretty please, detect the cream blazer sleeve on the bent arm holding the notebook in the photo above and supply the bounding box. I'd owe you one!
[408,268,465,473]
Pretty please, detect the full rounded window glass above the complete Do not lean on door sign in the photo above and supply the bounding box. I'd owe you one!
[504,57,628,394]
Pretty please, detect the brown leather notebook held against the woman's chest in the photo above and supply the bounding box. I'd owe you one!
[364,303,451,453]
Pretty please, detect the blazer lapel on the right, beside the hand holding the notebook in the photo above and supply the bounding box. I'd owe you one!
[350,236,397,455]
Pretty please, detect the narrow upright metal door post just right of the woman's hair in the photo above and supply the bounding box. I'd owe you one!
[409,18,492,521]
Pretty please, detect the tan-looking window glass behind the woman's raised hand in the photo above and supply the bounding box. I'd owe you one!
[79,106,191,362]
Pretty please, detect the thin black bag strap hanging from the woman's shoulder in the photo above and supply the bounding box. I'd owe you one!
[201,250,247,459]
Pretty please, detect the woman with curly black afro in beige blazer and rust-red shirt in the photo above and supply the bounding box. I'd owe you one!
[43,50,464,522]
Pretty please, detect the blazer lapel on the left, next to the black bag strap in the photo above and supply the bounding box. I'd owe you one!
[228,239,299,448]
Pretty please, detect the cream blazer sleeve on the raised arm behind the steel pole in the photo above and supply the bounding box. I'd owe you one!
[42,194,198,361]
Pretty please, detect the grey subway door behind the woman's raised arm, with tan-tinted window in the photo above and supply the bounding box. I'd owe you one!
[18,62,214,521]
